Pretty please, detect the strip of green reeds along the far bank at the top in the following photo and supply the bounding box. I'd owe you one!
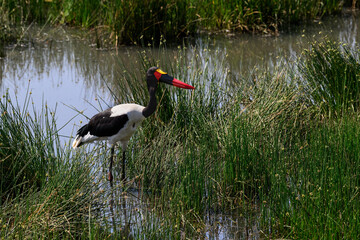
[0,0,352,44]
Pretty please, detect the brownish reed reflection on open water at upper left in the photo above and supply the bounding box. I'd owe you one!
[3,36,113,89]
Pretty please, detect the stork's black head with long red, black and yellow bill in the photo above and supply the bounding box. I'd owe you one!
[146,67,194,89]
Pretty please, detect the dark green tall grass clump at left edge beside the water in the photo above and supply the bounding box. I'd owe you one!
[0,94,57,200]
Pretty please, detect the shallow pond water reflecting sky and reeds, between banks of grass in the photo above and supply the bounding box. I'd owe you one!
[0,10,360,239]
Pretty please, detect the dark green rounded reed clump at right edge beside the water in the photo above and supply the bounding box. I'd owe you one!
[299,40,360,115]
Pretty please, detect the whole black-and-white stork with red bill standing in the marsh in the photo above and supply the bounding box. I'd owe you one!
[72,67,194,181]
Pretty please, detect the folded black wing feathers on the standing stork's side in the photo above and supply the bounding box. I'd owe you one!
[86,108,129,137]
